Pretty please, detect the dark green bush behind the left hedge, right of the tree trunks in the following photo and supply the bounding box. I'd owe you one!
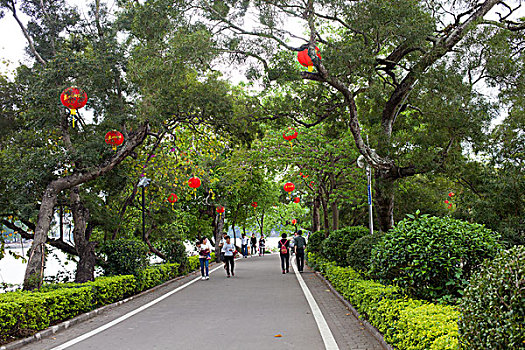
[101,239,149,276]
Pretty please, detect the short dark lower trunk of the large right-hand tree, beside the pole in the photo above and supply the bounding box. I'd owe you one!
[374,169,395,232]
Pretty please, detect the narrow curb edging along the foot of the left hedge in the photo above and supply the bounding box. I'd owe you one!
[0,262,216,350]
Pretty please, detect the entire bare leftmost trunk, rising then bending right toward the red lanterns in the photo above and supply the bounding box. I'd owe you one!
[24,123,149,290]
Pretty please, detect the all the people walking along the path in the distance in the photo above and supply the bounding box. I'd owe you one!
[197,230,306,280]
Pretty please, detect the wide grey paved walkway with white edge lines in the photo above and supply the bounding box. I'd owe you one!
[26,254,382,350]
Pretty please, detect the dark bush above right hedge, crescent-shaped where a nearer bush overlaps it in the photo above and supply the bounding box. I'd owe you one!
[321,226,369,266]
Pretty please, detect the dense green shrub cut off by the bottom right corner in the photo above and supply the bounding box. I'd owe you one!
[459,246,525,349]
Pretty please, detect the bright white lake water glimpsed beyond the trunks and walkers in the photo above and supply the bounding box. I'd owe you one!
[0,237,298,284]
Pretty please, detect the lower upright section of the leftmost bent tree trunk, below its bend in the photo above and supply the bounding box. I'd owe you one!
[24,183,60,290]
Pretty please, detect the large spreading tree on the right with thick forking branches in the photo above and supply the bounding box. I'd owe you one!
[195,0,525,230]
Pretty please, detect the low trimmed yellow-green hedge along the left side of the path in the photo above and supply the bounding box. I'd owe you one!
[0,257,190,343]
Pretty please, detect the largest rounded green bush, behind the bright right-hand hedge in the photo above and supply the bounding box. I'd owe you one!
[370,214,501,302]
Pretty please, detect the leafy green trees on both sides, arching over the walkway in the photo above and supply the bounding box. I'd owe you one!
[0,0,525,289]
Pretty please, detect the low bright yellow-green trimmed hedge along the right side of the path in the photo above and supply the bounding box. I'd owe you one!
[308,253,459,350]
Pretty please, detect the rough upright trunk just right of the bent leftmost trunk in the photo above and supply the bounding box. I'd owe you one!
[69,186,97,283]
